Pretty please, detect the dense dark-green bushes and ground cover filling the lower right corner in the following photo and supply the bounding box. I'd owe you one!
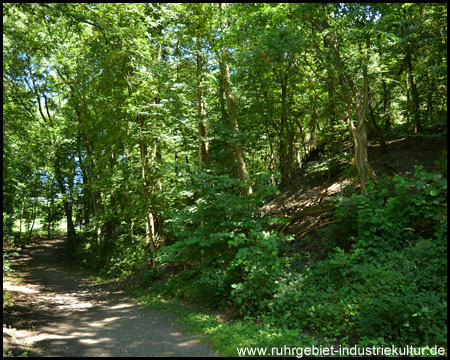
[270,167,447,346]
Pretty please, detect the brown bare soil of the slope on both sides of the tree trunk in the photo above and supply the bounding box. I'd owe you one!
[261,128,447,260]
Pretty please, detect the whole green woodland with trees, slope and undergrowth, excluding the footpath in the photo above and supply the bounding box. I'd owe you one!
[3,3,447,356]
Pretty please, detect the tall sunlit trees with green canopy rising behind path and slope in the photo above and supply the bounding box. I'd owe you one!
[3,3,447,352]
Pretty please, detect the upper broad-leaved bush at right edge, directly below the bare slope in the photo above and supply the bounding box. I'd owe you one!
[327,167,447,256]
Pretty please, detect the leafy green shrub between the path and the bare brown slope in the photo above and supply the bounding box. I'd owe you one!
[159,174,287,314]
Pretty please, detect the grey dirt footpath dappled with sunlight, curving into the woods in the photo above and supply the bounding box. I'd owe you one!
[3,239,220,357]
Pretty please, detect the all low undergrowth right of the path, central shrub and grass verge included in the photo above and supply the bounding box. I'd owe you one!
[77,167,447,356]
